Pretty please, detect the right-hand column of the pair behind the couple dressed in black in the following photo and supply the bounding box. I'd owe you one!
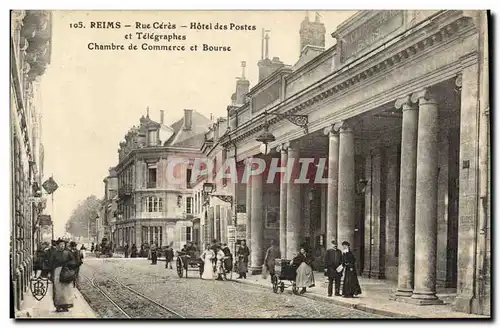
[337,122,356,245]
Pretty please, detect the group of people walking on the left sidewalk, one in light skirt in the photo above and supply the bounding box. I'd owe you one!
[33,238,85,312]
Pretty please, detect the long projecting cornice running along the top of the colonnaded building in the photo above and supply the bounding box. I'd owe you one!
[221,11,474,148]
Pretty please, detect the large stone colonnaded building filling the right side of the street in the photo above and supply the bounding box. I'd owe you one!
[218,10,491,314]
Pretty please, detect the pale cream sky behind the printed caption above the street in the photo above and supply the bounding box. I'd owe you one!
[40,11,354,236]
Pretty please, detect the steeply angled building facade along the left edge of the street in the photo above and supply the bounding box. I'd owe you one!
[10,10,52,310]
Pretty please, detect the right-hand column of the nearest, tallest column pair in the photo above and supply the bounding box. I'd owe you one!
[411,89,442,305]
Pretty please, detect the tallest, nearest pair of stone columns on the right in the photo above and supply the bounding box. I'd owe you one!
[395,89,440,304]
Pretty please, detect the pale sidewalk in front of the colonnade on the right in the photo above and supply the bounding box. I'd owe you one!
[235,272,489,319]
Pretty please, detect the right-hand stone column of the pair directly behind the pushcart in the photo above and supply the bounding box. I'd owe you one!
[286,144,302,259]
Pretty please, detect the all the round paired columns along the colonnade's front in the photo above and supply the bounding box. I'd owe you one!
[242,85,450,304]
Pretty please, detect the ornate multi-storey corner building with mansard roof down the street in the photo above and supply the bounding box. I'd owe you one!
[114,109,211,249]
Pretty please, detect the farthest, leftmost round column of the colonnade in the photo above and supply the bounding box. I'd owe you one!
[250,170,264,274]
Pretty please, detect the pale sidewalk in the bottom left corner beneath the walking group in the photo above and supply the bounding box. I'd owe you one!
[16,278,97,319]
